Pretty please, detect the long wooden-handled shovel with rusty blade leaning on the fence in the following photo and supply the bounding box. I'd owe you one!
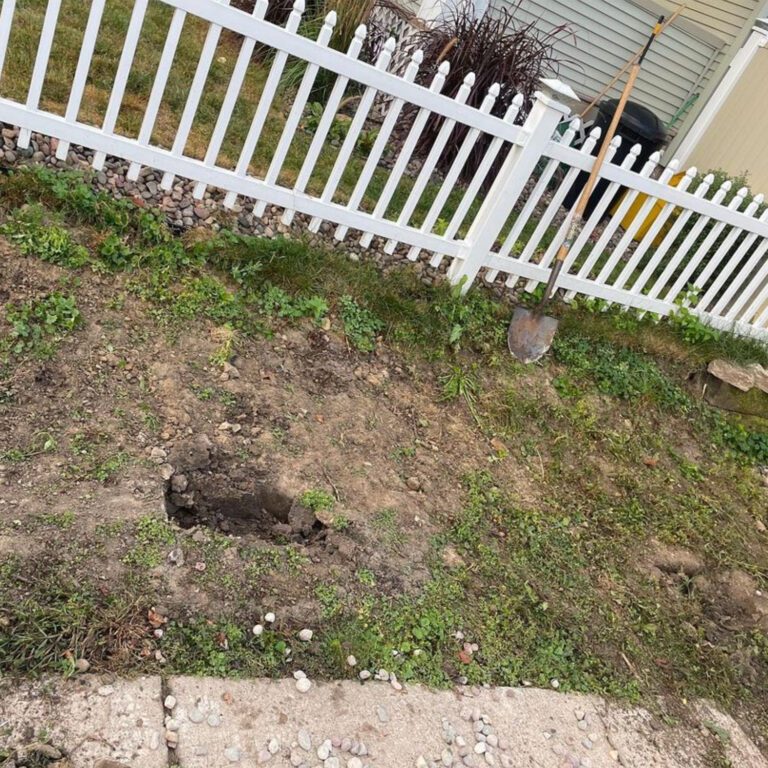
[507,16,664,363]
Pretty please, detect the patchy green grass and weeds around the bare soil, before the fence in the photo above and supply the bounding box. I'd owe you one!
[0,165,768,740]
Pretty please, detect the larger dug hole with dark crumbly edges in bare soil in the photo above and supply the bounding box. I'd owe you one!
[165,464,327,544]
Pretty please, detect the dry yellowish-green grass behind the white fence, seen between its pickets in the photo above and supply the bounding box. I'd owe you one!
[0,0,480,226]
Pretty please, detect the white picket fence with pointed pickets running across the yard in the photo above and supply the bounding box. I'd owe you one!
[0,0,768,338]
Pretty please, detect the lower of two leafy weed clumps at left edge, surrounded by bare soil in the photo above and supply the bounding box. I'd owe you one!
[6,293,82,357]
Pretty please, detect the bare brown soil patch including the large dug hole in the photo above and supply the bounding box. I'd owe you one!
[0,243,496,621]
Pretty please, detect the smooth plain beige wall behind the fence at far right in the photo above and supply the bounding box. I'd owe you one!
[688,48,768,194]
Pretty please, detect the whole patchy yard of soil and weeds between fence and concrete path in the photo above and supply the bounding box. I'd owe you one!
[0,166,768,752]
